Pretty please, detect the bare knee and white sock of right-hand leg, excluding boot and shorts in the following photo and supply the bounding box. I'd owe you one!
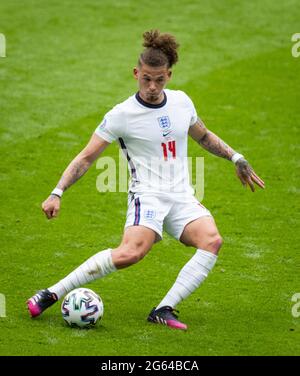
[157,216,222,309]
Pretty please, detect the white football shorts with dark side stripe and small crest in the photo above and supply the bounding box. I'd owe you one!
[125,193,212,240]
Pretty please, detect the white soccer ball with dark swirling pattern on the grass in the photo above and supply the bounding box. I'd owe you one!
[61,288,104,328]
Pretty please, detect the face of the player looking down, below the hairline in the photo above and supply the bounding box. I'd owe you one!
[133,64,172,104]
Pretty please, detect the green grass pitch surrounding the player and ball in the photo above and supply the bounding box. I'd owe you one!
[0,0,300,355]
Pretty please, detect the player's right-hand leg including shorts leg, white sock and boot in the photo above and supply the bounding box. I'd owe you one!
[148,195,222,330]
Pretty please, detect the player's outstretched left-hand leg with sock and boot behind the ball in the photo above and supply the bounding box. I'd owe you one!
[27,226,156,317]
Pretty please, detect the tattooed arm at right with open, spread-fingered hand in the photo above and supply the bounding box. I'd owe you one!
[189,118,265,192]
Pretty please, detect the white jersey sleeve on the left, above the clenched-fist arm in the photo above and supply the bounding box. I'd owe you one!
[95,106,125,143]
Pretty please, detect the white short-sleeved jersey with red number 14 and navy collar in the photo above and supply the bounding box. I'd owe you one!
[95,89,197,193]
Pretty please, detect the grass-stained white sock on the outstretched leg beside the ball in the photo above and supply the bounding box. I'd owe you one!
[48,249,116,299]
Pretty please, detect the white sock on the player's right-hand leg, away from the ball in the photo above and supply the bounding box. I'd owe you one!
[156,249,217,309]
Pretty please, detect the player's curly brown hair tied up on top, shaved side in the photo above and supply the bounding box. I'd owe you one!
[138,30,179,68]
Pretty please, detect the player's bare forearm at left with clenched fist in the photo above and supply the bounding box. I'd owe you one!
[42,133,109,219]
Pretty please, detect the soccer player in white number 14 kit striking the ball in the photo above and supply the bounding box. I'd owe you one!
[27,30,264,330]
